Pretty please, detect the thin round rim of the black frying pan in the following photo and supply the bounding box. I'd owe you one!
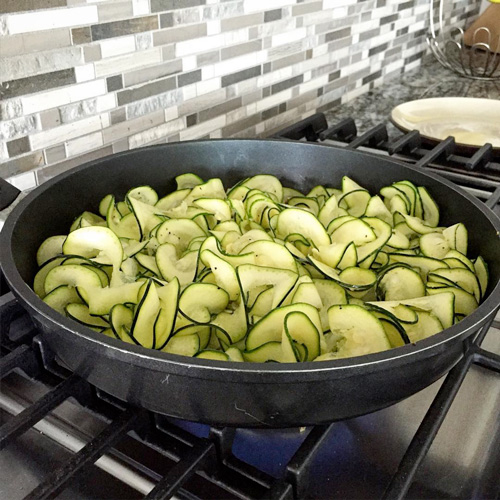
[0,139,500,383]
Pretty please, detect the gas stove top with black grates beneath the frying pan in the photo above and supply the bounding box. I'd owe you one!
[0,114,500,499]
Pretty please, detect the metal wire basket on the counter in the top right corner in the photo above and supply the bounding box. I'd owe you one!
[427,0,500,80]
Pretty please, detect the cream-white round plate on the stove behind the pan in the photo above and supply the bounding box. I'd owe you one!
[391,97,500,148]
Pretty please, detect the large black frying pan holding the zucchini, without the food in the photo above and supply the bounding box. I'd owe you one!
[0,140,500,427]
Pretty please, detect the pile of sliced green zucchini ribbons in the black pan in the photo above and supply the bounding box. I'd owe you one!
[34,173,488,363]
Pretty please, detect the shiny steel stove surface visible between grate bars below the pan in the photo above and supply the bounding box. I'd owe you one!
[0,314,500,500]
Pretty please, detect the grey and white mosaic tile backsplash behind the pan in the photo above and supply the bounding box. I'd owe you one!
[0,0,479,189]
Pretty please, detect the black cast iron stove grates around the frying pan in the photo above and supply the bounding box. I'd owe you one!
[0,115,500,499]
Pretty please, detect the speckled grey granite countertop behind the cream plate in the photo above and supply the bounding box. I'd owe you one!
[325,55,500,137]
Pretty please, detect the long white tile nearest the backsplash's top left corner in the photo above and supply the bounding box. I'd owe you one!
[7,5,98,35]
